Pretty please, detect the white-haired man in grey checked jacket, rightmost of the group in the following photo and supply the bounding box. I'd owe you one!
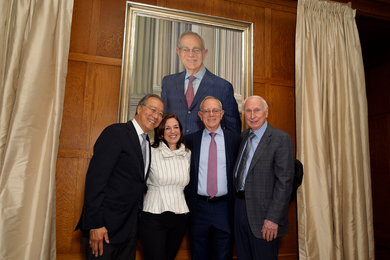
[234,96,294,260]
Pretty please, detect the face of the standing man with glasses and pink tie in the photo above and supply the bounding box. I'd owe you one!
[198,98,225,132]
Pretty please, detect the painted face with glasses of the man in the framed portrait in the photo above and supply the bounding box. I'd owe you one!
[176,34,208,75]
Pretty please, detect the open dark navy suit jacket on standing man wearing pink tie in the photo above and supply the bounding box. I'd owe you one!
[184,129,241,225]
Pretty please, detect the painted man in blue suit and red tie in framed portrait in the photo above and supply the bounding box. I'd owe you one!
[161,31,241,135]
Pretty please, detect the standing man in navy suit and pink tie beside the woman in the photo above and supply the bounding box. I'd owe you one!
[185,96,241,260]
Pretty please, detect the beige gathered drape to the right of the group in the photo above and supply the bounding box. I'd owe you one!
[295,0,374,260]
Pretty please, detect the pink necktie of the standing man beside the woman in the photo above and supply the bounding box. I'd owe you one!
[207,133,218,198]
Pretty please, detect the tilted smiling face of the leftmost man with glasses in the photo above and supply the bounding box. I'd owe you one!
[134,97,164,133]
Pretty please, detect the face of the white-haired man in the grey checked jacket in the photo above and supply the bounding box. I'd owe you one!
[244,97,268,131]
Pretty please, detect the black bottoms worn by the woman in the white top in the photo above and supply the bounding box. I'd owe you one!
[139,212,188,260]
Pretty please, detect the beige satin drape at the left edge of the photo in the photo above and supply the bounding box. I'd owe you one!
[0,0,73,260]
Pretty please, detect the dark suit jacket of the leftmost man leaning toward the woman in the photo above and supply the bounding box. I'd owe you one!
[76,121,150,244]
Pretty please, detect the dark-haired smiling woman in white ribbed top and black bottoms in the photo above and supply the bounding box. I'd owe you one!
[139,114,191,260]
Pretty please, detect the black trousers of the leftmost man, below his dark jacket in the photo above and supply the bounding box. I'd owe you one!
[82,220,138,260]
